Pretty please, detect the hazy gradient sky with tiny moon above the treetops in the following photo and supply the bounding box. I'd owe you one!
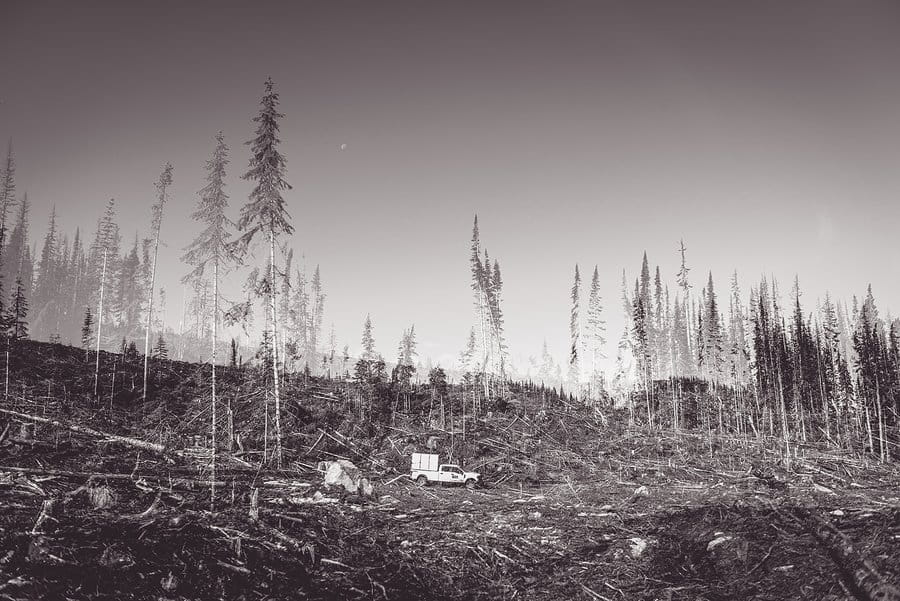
[0,0,900,376]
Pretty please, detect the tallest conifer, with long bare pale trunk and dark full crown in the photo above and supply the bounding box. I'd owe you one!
[236,78,294,467]
